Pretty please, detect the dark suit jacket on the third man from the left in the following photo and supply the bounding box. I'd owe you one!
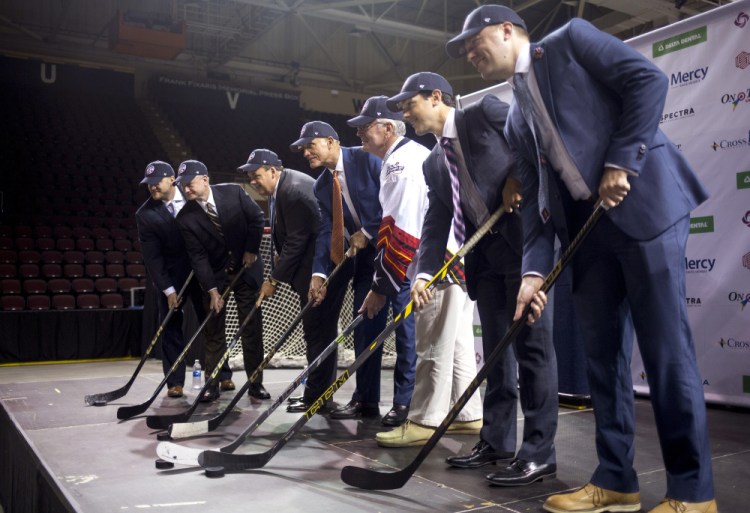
[271,169,320,295]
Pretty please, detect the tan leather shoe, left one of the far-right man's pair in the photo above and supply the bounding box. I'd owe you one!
[542,483,641,513]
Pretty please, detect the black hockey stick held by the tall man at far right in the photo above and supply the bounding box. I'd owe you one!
[341,203,605,490]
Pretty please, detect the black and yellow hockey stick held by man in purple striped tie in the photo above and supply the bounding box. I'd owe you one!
[191,207,504,471]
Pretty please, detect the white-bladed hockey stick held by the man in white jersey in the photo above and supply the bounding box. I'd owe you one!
[156,315,364,465]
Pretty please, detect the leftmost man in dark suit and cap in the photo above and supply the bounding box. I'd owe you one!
[135,160,203,397]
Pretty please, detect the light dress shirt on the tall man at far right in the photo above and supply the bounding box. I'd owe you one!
[508,43,591,200]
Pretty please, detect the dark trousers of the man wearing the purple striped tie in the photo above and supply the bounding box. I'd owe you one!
[475,235,558,464]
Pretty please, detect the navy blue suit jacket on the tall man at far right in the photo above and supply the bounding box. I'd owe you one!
[505,19,708,274]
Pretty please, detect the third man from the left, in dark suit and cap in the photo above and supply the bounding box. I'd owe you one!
[238,149,338,412]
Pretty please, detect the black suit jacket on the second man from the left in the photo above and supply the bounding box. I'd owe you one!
[177,184,265,293]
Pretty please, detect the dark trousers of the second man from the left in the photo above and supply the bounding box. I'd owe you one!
[203,277,263,383]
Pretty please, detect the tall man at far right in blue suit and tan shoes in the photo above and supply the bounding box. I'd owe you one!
[447,5,717,513]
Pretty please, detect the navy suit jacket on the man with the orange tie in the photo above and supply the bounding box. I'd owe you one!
[313,146,383,274]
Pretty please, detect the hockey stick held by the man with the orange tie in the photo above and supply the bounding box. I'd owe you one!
[169,251,351,438]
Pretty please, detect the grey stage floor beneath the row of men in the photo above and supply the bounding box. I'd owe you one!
[0,361,750,513]
